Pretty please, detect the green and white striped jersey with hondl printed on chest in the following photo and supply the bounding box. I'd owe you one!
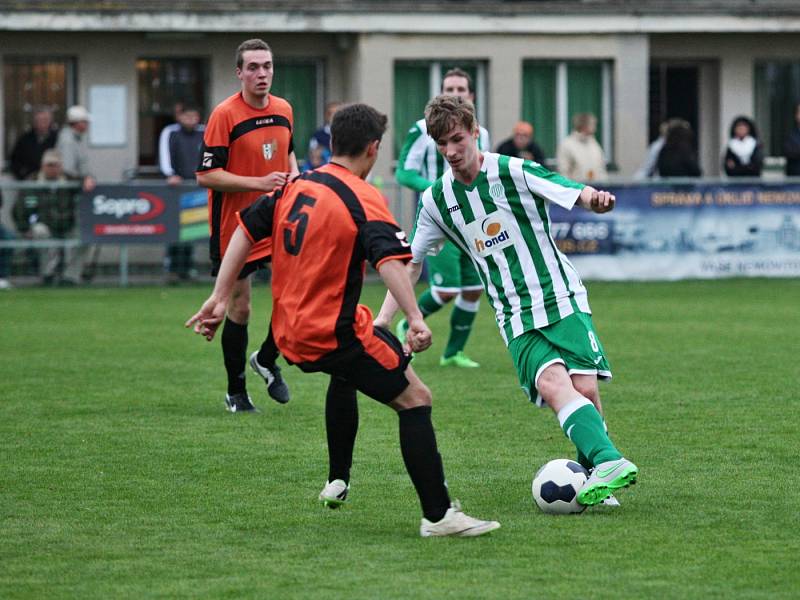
[411,152,591,344]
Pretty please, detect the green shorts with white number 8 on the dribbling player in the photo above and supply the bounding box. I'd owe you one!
[508,312,611,406]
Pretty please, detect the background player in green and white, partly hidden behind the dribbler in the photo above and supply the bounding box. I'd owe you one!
[395,69,490,368]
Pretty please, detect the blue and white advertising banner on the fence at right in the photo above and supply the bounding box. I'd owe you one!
[550,181,800,280]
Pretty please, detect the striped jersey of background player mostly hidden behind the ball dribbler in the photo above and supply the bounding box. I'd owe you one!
[395,119,490,192]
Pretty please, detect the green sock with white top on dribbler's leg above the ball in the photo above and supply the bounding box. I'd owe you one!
[558,396,622,467]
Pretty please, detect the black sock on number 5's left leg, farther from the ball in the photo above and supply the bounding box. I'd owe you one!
[325,376,358,483]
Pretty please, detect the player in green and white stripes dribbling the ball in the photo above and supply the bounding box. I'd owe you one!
[375,96,638,505]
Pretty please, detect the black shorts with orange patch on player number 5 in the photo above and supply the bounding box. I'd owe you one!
[297,327,411,404]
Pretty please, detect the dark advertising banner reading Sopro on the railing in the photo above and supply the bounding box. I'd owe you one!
[79,184,208,244]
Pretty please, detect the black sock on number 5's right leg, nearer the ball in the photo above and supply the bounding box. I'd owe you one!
[397,406,450,522]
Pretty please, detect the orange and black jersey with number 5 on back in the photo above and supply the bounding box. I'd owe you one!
[239,163,411,363]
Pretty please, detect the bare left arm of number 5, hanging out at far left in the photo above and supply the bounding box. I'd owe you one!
[184,227,253,342]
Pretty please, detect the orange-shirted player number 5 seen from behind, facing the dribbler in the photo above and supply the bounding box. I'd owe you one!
[186,104,500,537]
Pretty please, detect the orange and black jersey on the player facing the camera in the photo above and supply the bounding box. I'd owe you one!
[197,92,294,264]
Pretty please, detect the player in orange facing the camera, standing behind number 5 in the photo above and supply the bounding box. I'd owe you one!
[197,39,298,412]
